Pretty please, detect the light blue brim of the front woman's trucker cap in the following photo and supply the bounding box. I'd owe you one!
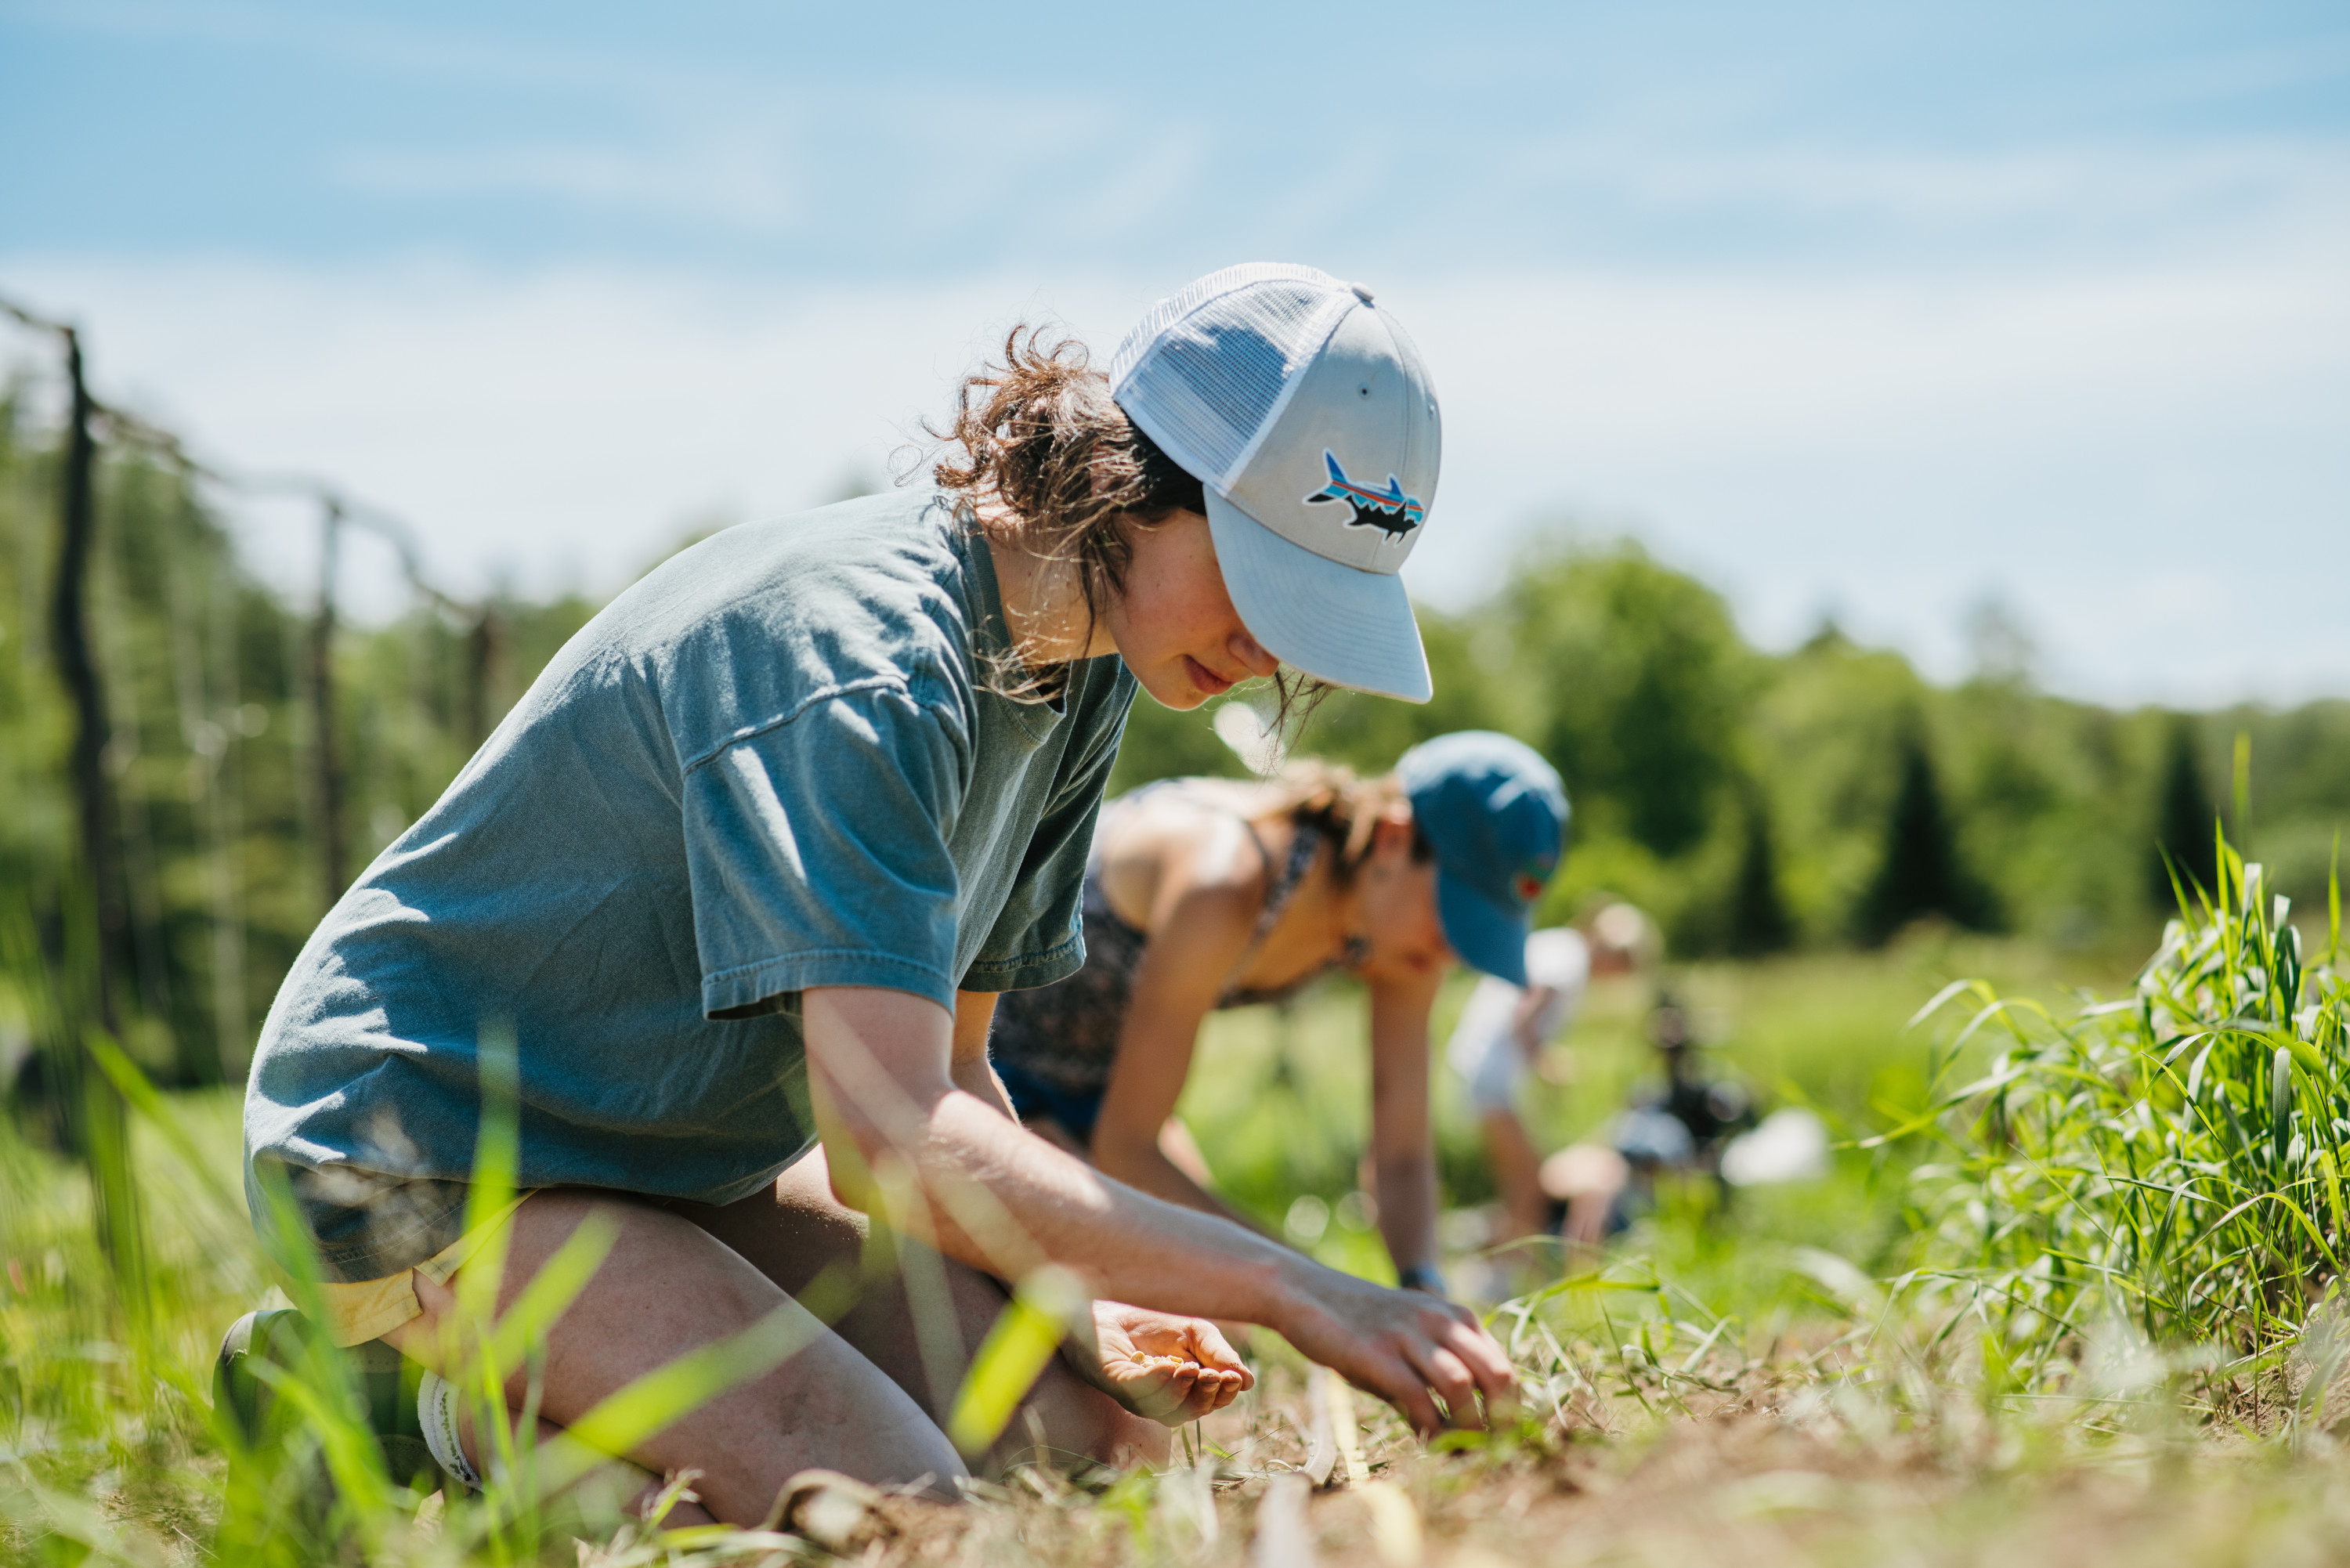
[1208,489,1434,703]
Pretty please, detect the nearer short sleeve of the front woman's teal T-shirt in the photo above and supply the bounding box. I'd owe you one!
[684,684,971,1018]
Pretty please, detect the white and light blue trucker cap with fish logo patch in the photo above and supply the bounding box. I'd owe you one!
[1109,261,1438,703]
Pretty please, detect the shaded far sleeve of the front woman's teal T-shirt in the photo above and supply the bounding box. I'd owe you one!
[961,660,1135,992]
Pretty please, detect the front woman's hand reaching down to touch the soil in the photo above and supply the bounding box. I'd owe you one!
[1274,1260,1518,1436]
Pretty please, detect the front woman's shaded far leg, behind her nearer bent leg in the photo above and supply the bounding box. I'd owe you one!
[674,1150,1170,1472]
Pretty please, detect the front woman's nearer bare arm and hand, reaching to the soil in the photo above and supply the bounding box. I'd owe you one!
[801,988,1513,1432]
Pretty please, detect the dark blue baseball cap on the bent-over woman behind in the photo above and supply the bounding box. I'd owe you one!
[1396,728,1567,985]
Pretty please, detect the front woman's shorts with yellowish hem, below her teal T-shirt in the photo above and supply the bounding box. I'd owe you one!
[287,1166,531,1347]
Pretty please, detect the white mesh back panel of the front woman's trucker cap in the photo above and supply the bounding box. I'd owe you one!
[1109,263,1354,486]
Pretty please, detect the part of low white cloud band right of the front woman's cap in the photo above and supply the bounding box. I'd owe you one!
[1398,251,2350,700]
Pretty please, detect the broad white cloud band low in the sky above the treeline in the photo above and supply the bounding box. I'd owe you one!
[0,247,2350,700]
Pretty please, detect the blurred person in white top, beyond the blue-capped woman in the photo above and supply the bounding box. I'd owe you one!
[1445,903,1657,1239]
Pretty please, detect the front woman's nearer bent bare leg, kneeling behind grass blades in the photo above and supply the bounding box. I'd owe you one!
[383,1190,964,1523]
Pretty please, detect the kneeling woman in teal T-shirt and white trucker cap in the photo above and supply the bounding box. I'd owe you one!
[229,266,1511,1523]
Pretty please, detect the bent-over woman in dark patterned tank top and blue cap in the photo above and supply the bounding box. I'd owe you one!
[992,731,1567,1293]
